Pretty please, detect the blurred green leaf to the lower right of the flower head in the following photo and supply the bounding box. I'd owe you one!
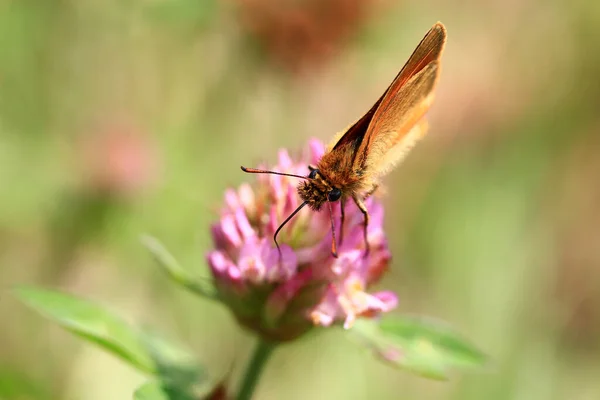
[350,315,487,379]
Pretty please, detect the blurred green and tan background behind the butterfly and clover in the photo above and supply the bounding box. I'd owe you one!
[0,0,600,400]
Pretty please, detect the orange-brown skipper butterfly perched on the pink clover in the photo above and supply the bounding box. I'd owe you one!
[242,22,446,257]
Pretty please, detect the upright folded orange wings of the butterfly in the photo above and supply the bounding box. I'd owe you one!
[332,22,446,178]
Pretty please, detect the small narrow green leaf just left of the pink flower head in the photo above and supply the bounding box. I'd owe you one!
[141,235,217,300]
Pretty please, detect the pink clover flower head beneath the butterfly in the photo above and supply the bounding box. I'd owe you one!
[207,140,397,341]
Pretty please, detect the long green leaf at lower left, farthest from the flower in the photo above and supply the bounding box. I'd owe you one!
[15,287,156,373]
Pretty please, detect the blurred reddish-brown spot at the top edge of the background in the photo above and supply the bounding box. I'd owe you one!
[236,0,381,73]
